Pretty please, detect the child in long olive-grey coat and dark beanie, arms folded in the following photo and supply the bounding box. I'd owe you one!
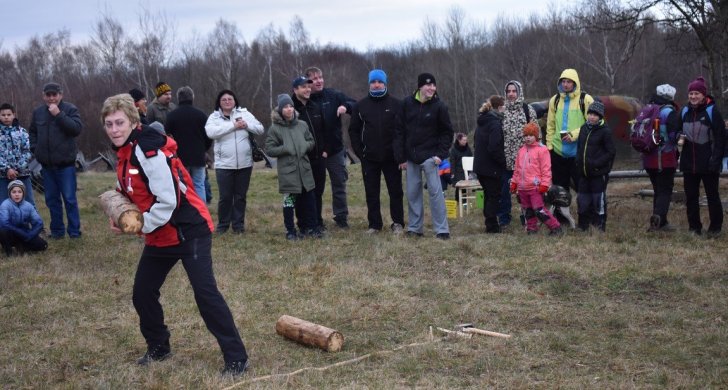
[265,94,321,240]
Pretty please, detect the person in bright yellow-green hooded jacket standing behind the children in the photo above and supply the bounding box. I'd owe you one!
[546,69,594,228]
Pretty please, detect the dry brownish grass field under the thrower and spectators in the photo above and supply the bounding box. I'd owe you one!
[0,165,728,389]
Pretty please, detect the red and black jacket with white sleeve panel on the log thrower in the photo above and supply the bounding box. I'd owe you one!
[116,126,214,247]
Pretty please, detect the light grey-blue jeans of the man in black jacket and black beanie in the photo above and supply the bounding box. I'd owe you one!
[407,158,450,234]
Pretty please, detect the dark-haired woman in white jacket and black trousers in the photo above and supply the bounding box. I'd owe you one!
[205,89,264,234]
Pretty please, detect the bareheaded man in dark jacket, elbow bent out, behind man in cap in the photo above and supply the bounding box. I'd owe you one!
[306,67,356,228]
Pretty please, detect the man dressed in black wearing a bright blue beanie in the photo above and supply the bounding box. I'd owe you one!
[349,69,404,234]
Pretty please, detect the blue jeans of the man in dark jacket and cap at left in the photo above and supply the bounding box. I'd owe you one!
[41,165,81,238]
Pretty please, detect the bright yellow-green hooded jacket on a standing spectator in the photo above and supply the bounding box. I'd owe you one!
[546,69,594,157]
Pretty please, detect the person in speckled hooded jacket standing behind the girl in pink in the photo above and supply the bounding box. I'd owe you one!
[498,80,538,228]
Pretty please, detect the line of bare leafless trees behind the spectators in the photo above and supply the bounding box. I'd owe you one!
[0,0,728,158]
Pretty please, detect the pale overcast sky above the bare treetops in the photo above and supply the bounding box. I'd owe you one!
[0,0,552,52]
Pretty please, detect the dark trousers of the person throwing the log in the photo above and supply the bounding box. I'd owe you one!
[132,235,248,362]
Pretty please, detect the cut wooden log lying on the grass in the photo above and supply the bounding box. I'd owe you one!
[276,314,344,352]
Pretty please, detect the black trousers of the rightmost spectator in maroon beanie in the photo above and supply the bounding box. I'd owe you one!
[683,172,723,233]
